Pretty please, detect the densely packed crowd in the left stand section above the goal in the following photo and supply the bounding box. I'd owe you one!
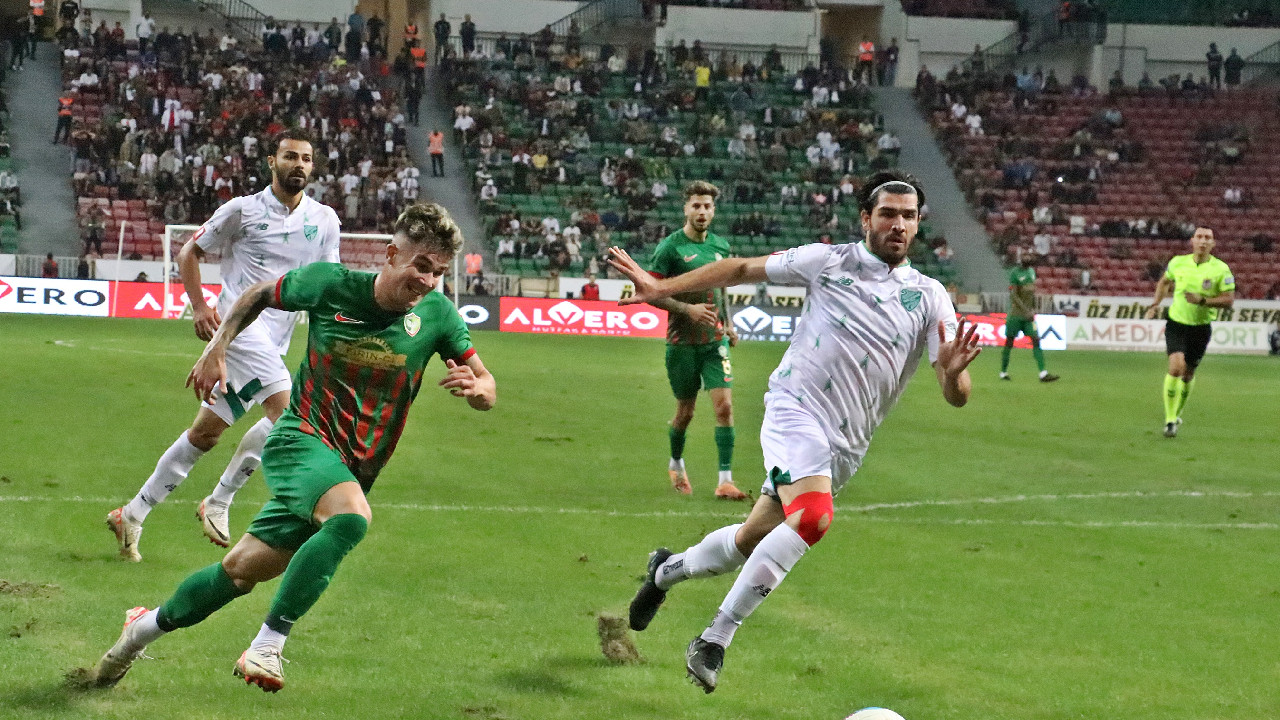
[55,13,409,255]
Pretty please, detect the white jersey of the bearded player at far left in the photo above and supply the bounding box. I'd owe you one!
[192,186,342,355]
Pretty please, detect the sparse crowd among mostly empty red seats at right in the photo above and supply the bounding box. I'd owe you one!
[915,47,1275,297]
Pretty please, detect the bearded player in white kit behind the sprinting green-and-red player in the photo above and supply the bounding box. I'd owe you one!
[106,129,340,562]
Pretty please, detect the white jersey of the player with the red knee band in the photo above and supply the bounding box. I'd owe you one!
[764,242,956,462]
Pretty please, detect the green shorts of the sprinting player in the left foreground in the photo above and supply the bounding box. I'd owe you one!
[246,429,357,551]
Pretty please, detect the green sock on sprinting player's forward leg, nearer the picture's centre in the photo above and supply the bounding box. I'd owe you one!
[266,514,369,635]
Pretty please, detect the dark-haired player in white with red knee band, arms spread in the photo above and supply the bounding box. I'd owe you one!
[609,170,979,693]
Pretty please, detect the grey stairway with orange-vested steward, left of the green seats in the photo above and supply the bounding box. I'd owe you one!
[406,70,494,260]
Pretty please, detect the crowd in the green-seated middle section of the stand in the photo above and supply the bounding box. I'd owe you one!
[442,32,957,283]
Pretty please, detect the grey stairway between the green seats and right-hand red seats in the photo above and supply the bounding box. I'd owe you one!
[874,87,1009,292]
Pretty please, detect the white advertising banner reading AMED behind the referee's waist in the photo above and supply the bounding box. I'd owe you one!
[1066,318,1271,355]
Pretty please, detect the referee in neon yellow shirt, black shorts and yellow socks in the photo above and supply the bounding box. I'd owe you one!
[1147,227,1235,437]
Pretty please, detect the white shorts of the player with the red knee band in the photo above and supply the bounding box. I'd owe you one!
[760,392,861,497]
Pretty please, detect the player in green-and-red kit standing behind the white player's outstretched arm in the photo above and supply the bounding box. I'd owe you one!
[649,181,749,500]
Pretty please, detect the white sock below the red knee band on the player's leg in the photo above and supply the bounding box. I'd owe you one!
[703,523,809,647]
